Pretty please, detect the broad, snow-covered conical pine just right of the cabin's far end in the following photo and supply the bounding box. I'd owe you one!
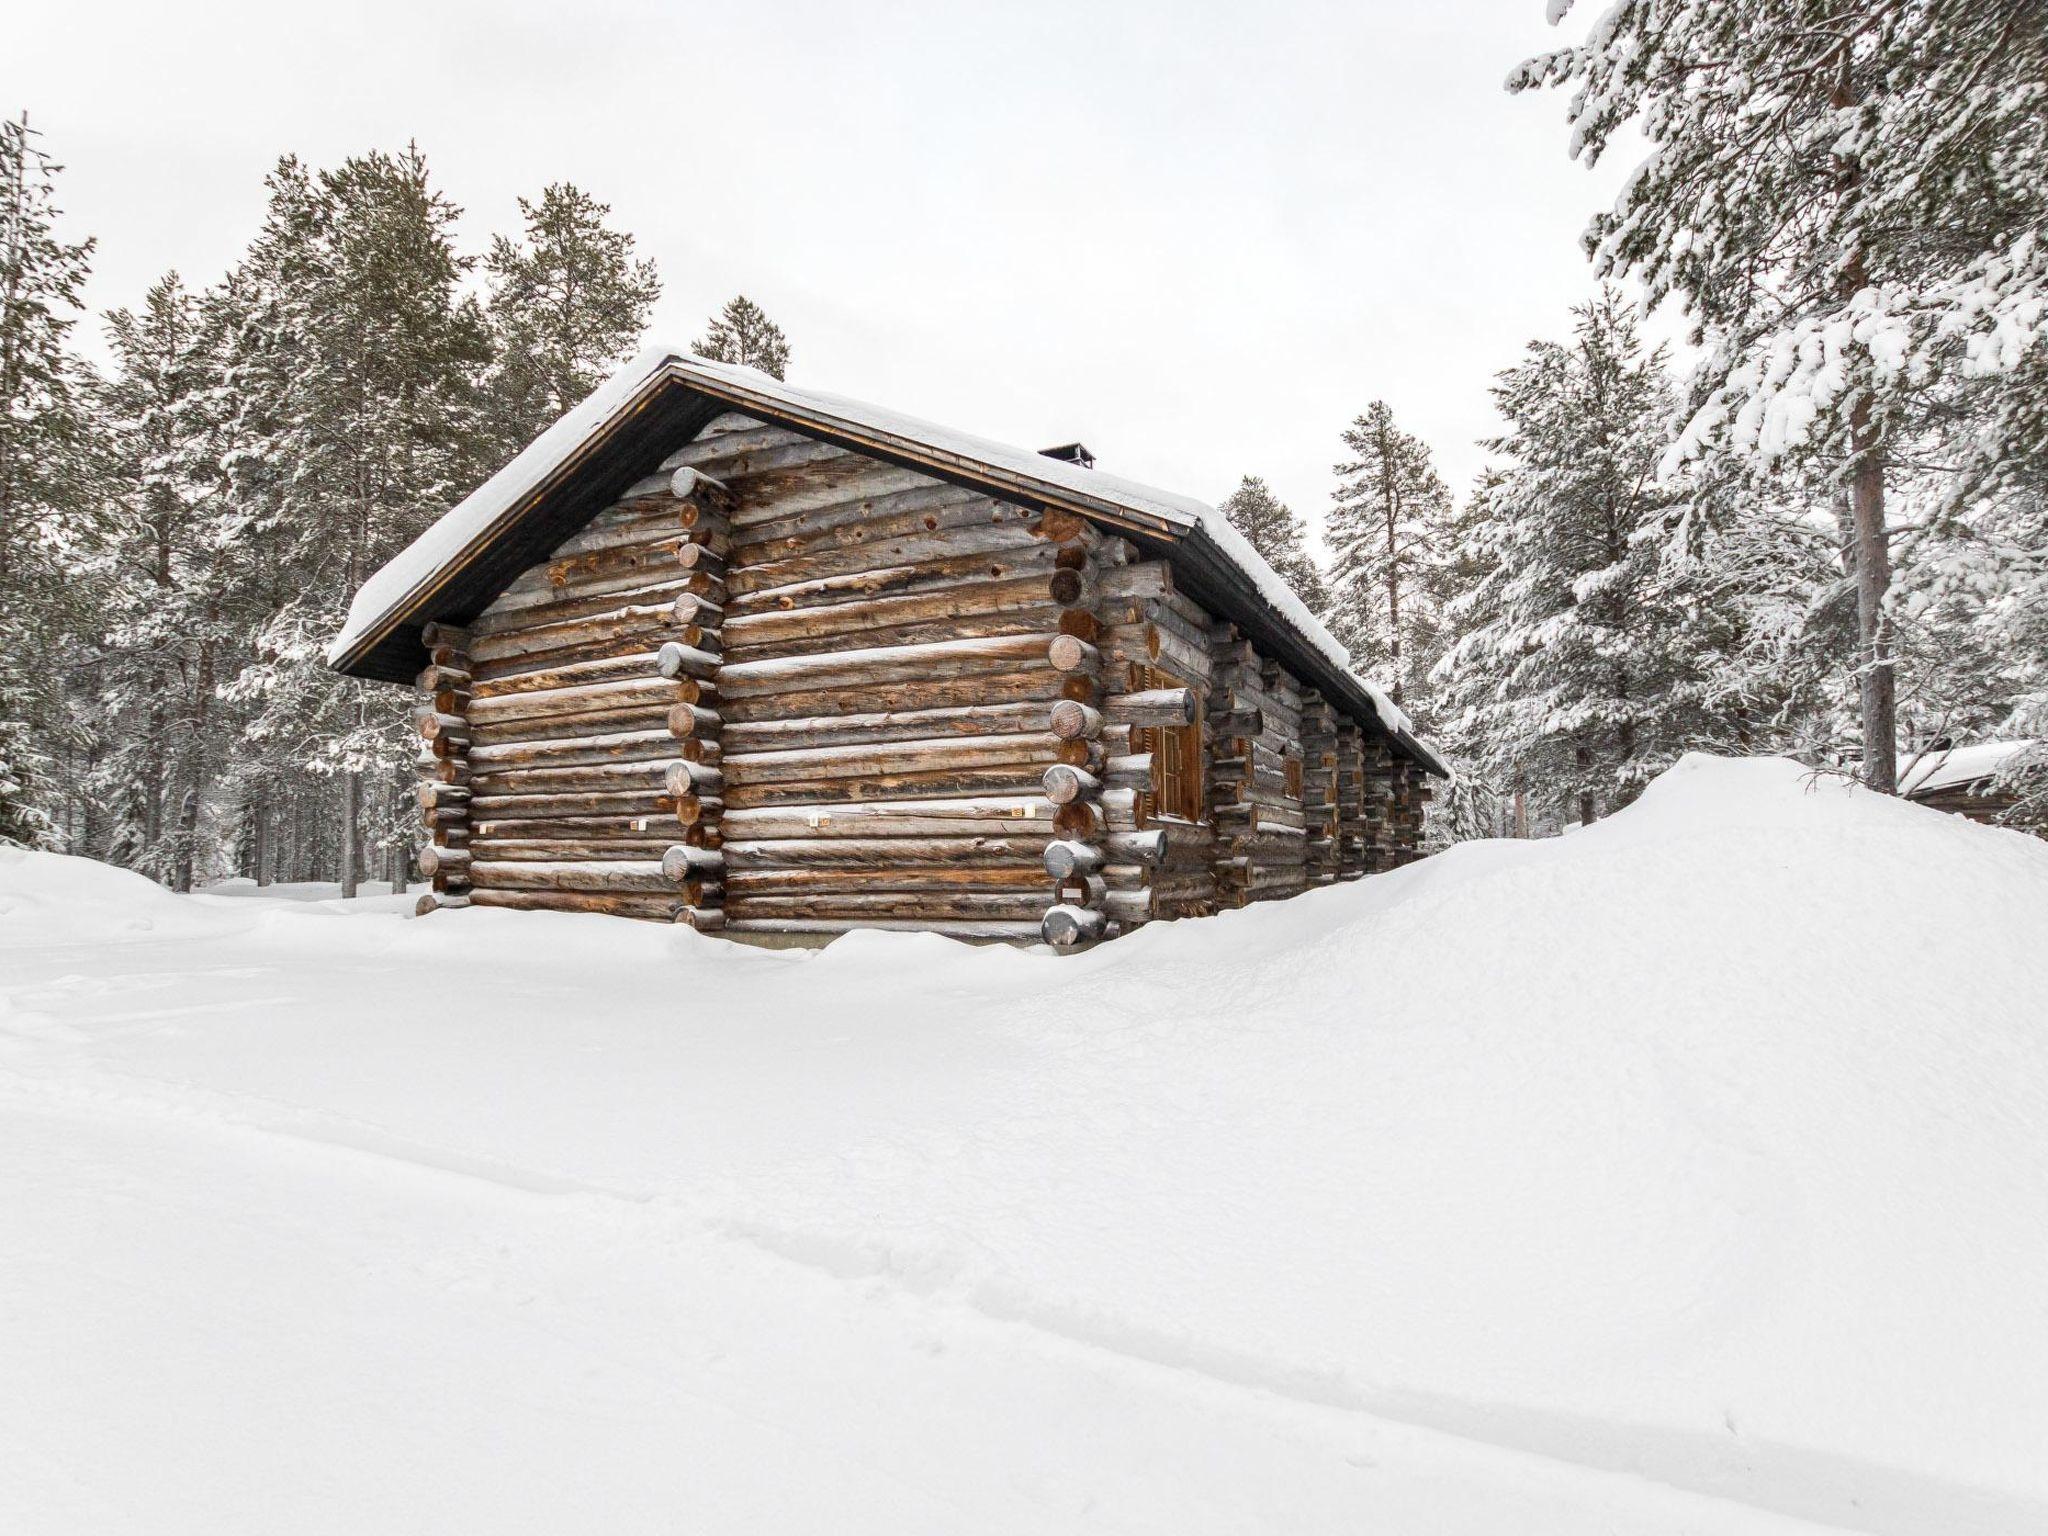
[1438,291,1710,835]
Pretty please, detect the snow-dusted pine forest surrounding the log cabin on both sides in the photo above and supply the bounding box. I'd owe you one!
[0,0,2048,891]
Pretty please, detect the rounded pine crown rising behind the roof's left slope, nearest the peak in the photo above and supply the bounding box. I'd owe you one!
[485,182,662,453]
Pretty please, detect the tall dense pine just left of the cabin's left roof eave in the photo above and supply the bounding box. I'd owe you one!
[231,147,487,895]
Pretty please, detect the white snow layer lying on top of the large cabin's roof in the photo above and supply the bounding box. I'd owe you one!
[328,354,1450,778]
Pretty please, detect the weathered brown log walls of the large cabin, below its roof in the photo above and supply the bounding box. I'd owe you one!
[418,414,1419,946]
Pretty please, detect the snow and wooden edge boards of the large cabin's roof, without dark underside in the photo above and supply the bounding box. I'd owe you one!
[328,344,1450,776]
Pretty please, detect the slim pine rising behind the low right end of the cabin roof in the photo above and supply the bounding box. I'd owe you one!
[1329,409,1450,720]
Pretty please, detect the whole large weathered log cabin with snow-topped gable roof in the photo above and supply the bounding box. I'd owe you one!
[330,348,1446,946]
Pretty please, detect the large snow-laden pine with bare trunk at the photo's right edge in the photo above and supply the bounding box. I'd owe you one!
[1509,0,2048,791]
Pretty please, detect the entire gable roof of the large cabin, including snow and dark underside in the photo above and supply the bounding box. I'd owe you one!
[328,346,1450,776]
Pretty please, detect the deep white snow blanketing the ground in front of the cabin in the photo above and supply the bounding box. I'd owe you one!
[0,760,2048,1536]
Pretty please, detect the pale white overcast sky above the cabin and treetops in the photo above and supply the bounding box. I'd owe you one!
[0,0,1626,548]
